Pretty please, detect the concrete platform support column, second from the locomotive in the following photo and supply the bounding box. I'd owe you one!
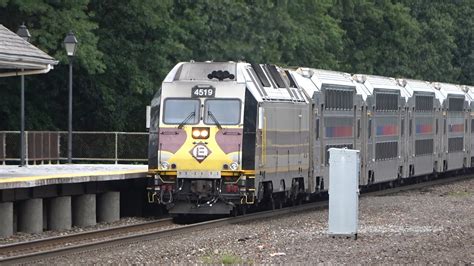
[72,194,97,227]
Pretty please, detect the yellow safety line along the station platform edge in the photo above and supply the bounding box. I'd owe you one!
[0,170,148,184]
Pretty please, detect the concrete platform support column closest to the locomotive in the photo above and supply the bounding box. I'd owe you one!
[97,191,120,223]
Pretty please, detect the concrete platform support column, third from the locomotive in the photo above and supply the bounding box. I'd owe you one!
[48,196,72,231]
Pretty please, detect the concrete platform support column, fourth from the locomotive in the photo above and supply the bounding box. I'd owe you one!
[18,199,43,233]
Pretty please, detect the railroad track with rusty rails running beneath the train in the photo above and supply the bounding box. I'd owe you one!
[0,174,474,265]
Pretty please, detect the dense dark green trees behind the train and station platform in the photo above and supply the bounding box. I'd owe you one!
[0,0,474,131]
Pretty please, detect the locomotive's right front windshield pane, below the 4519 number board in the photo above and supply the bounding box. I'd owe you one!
[204,99,241,125]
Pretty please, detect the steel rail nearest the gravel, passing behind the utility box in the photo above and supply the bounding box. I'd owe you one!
[0,174,474,264]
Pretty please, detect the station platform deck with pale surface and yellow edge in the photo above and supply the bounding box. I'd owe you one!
[0,164,148,190]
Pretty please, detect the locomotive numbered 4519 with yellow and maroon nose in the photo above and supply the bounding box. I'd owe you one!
[148,62,311,214]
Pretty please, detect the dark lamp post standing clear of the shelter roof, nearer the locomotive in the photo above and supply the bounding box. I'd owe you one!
[64,31,77,163]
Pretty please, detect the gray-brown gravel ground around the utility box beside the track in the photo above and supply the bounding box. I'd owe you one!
[43,179,474,264]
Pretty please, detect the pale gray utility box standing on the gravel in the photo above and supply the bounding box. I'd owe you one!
[329,148,360,239]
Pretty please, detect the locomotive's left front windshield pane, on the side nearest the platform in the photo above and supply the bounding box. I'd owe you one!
[163,98,200,124]
